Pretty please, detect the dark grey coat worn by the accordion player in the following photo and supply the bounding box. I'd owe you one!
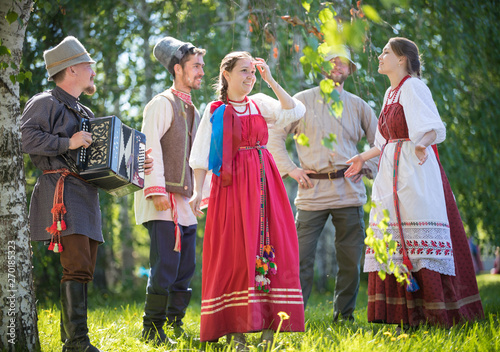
[21,87,104,242]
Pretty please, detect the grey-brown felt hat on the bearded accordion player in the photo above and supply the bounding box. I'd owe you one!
[43,36,95,81]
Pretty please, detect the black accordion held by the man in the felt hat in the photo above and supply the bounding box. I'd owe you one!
[77,116,146,197]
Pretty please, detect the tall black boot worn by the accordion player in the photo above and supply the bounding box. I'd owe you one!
[61,281,100,352]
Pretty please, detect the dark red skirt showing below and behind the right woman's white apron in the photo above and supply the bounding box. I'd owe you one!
[368,163,484,328]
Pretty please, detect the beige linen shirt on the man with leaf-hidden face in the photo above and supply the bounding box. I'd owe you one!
[268,87,378,211]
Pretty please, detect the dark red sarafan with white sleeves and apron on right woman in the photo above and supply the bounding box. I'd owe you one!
[364,78,484,328]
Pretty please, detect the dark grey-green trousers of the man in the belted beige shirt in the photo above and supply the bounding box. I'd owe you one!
[295,207,365,320]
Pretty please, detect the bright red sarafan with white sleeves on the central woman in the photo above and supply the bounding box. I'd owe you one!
[190,94,305,341]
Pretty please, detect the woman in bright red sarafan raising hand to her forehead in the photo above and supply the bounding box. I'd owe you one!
[189,52,305,345]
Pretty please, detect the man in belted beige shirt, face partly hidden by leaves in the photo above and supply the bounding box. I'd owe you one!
[268,47,377,321]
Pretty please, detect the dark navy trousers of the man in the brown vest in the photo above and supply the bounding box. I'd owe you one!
[144,220,196,296]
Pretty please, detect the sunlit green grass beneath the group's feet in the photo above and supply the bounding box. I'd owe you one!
[38,274,500,352]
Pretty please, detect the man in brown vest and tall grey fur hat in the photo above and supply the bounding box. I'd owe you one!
[135,37,205,344]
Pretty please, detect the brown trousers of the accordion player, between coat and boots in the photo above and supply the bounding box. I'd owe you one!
[60,234,99,284]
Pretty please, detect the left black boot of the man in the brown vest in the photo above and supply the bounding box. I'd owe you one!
[142,294,177,345]
